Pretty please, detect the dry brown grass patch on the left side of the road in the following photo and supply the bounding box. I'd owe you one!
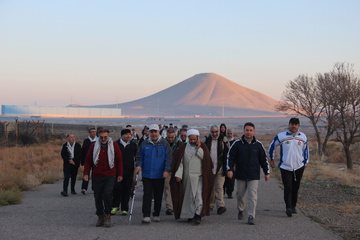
[0,141,63,206]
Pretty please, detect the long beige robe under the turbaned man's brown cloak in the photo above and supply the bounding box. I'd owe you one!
[175,143,204,218]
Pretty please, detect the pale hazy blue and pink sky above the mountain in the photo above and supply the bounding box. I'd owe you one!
[0,0,360,106]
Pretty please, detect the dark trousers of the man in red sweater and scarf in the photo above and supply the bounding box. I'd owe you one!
[93,176,115,216]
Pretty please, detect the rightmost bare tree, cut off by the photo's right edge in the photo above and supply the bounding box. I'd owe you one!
[327,63,360,170]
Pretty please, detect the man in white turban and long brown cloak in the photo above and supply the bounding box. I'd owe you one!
[170,129,213,224]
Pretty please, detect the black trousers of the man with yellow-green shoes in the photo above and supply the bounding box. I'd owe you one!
[112,173,133,211]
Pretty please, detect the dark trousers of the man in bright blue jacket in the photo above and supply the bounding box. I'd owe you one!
[142,177,165,217]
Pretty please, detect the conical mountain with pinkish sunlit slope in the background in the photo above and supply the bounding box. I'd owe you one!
[98,73,276,116]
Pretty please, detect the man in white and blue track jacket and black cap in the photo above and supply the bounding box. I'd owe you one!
[269,118,309,217]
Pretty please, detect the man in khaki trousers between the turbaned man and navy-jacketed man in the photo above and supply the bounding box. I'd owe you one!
[205,125,230,214]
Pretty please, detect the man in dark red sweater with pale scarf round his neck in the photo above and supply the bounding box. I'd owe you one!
[84,129,123,227]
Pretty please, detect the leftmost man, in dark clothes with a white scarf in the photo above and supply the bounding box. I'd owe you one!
[61,134,81,197]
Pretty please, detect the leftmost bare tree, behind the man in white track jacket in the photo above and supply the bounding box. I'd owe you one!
[276,75,326,155]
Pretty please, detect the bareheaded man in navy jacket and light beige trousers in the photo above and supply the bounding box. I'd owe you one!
[227,122,270,225]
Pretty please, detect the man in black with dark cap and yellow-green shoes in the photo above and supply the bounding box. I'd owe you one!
[111,128,137,216]
